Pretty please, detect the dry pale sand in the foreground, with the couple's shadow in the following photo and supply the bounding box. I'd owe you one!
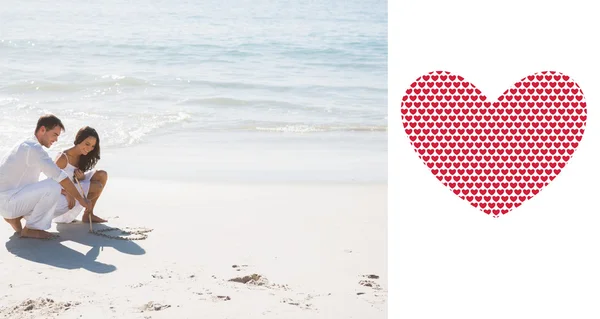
[0,178,387,319]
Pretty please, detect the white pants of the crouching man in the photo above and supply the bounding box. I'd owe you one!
[0,178,61,230]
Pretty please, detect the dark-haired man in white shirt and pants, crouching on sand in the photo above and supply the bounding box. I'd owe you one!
[0,114,91,239]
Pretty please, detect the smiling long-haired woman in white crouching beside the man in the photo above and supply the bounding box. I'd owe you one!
[54,126,108,223]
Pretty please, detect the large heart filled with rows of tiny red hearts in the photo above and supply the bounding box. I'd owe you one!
[401,71,587,217]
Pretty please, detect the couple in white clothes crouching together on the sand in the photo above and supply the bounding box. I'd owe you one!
[0,115,108,239]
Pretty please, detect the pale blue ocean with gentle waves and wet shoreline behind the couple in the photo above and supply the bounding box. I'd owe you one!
[0,0,387,179]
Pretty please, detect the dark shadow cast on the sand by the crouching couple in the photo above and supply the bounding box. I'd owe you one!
[6,223,146,274]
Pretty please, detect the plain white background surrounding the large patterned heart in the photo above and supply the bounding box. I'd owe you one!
[388,0,600,319]
